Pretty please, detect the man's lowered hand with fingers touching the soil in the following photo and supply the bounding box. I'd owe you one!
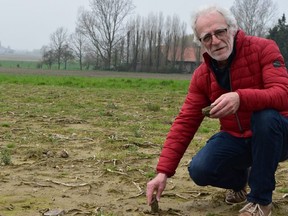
[146,173,167,205]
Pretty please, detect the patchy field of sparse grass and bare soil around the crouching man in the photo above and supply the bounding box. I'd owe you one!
[0,74,288,216]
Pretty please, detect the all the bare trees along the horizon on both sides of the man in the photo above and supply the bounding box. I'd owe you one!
[42,0,288,72]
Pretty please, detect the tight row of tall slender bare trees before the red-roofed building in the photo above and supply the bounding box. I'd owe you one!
[119,13,188,72]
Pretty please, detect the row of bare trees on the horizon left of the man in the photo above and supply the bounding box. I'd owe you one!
[42,0,192,71]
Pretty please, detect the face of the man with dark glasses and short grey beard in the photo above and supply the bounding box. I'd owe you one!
[196,11,234,61]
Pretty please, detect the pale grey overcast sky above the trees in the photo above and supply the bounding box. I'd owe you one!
[0,0,288,50]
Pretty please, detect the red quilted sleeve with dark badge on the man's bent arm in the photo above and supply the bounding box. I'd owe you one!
[237,39,288,111]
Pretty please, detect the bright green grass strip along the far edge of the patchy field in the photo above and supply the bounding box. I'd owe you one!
[0,74,189,92]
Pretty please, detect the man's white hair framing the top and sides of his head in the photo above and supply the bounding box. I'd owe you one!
[191,5,238,43]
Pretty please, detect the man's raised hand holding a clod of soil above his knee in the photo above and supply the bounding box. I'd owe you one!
[210,92,240,118]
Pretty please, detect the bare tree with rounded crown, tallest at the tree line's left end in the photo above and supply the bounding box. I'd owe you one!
[50,27,68,69]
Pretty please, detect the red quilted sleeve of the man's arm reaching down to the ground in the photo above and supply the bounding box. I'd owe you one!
[157,71,209,177]
